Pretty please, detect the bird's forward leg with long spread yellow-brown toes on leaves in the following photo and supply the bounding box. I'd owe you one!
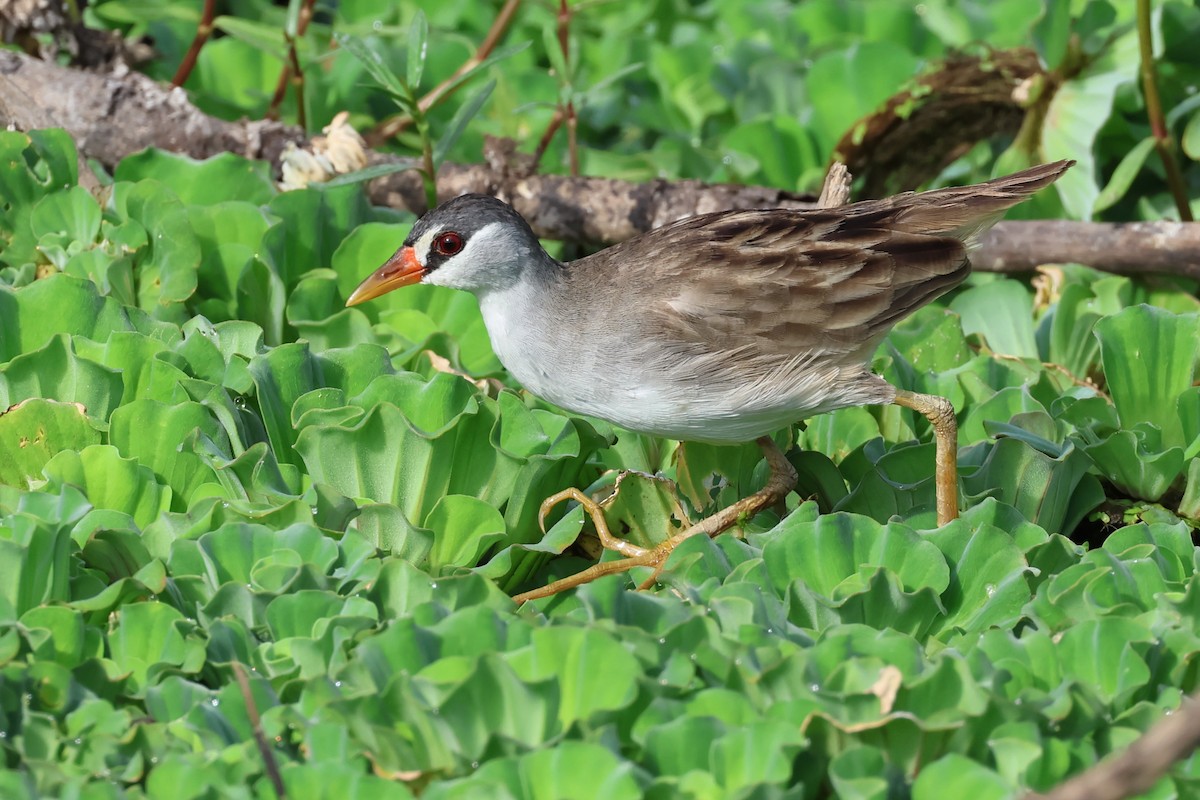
[512,437,796,603]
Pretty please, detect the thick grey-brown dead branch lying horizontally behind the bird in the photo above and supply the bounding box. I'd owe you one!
[0,50,1200,279]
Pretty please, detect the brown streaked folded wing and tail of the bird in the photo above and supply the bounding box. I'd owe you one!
[571,162,1069,361]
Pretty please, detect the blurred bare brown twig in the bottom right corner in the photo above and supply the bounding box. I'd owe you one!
[1025,694,1200,800]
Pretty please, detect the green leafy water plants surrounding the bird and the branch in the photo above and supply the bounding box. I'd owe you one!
[0,0,1200,800]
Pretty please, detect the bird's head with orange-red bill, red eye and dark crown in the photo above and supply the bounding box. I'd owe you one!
[346,194,550,306]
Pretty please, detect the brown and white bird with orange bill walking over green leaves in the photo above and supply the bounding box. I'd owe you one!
[346,161,1074,601]
